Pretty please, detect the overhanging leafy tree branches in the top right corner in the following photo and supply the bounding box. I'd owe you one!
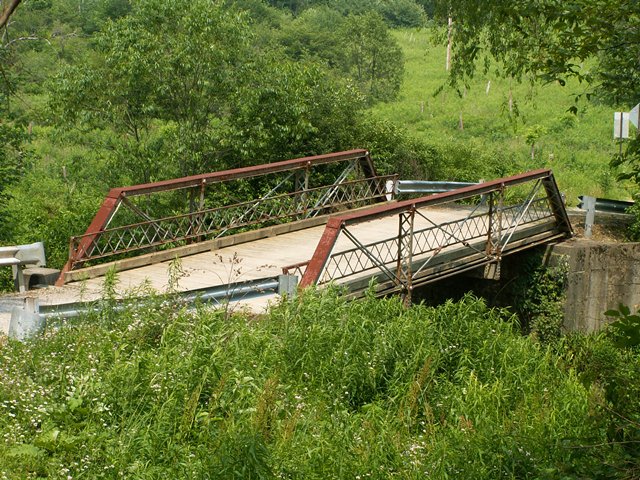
[434,0,640,102]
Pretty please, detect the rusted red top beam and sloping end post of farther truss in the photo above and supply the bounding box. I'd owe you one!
[56,149,376,285]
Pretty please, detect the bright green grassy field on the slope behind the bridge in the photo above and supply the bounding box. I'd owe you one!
[372,30,630,205]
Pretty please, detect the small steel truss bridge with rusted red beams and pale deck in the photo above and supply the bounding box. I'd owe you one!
[54,150,572,303]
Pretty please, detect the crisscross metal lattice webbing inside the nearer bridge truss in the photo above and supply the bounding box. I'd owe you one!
[319,188,554,284]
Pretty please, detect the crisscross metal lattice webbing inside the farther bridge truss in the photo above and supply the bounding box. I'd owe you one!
[71,160,394,261]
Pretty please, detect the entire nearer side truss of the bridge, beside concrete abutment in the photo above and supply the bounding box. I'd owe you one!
[298,170,572,296]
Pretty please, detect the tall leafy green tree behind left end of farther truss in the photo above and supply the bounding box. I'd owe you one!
[52,0,249,181]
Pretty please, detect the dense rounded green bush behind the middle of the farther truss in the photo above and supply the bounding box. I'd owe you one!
[220,57,362,165]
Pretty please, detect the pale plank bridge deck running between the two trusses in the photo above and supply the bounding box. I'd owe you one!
[0,207,468,331]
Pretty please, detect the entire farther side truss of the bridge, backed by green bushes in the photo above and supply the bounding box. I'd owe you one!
[61,150,396,278]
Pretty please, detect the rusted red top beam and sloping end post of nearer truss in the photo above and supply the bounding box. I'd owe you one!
[300,169,571,288]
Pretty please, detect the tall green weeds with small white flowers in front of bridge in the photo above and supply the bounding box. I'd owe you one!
[0,290,625,479]
